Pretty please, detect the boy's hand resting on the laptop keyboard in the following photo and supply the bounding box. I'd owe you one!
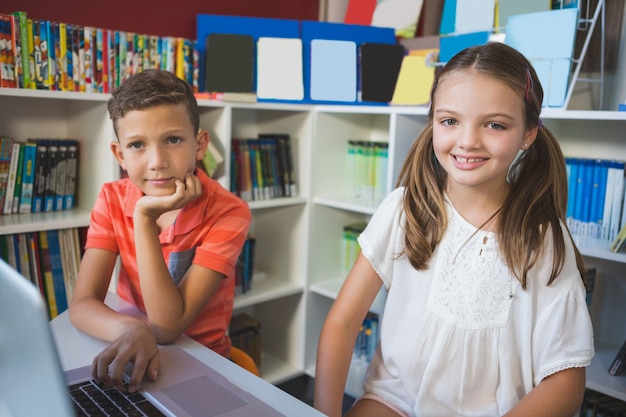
[91,323,161,392]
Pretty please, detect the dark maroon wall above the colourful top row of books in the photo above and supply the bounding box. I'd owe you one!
[2,0,319,39]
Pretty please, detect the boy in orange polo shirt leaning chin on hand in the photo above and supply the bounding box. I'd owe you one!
[69,70,251,392]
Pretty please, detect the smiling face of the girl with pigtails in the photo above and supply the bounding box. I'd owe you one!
[433,69,537,197]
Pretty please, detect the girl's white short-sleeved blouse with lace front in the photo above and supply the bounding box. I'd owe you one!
[359,188,594,417]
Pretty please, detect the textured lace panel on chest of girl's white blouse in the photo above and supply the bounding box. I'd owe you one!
[428,205,519,329]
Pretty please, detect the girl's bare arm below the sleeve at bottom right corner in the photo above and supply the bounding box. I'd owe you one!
[505,368,585,417]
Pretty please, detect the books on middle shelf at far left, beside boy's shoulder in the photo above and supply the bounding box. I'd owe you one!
[0,137,80,214]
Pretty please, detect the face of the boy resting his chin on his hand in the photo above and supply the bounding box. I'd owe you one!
[111,104,209,196]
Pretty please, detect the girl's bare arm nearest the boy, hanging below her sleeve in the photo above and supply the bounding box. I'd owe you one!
[314,250,382,417]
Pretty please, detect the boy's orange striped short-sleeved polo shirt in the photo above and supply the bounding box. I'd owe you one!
[85,170,251,356]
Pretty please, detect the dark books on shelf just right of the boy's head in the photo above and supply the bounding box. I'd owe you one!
[230,133,297,201]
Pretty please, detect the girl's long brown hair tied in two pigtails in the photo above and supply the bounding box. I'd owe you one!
[397,42,585,288]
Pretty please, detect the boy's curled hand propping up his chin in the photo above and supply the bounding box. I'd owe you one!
[135,174,202,220]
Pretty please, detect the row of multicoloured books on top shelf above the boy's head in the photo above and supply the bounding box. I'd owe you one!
[0,11,198,93]
